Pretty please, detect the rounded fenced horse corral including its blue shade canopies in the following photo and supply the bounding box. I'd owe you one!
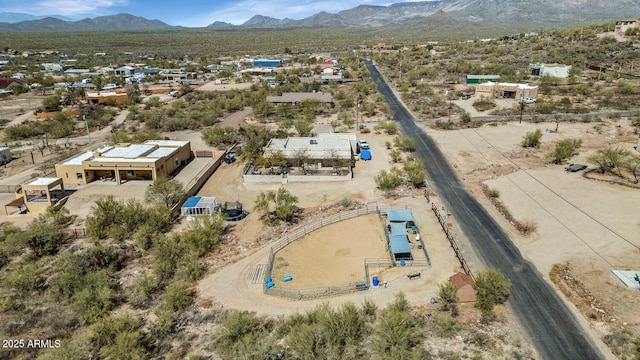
[265,205,430,300]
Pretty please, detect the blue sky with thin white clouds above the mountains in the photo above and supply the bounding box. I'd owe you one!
[0,0,424,27]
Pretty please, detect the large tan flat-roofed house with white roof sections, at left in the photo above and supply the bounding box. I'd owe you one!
[56,140,192,185]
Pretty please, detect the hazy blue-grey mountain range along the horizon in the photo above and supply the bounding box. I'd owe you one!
[0,0,640,32]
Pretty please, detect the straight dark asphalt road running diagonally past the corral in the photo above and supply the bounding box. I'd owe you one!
[365,61,604,360]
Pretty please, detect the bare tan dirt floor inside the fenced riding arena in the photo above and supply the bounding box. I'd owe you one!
[271,214,389,289]
